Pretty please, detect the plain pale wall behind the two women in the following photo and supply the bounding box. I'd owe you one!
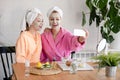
[0,0,99,50]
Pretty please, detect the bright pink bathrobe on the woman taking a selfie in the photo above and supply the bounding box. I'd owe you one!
[40,27,85,62]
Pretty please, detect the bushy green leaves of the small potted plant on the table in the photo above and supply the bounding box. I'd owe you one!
[92,52,120,69]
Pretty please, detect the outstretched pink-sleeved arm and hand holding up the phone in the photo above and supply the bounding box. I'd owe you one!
[66,30,88,51]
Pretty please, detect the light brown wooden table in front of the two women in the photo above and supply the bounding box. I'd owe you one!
[12,62,120,80]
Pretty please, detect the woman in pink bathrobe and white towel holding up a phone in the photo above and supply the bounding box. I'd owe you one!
[40,6,88,62]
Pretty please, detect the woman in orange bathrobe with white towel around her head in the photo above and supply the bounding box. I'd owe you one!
[16,8,43,63]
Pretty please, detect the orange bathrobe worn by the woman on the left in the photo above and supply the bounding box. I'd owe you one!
[16,31,42,63]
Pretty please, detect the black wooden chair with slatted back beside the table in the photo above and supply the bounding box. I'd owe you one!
[0,46,15,80]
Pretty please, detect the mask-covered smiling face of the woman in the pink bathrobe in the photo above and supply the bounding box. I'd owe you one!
[49,11,61,29]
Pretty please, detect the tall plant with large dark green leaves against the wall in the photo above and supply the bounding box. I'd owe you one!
[82,0,120,43]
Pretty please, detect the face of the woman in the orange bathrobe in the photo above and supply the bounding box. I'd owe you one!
[32,14,43,31]
